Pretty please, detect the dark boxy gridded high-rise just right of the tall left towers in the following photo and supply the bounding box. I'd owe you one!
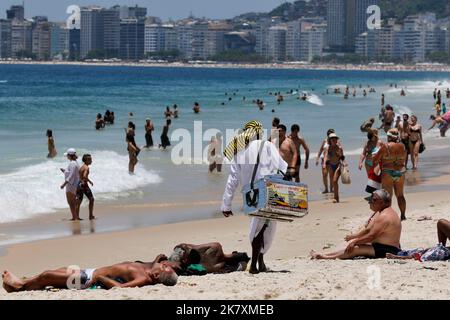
[120,18,145,60]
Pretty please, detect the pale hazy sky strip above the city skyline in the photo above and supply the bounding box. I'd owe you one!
[0,0,286,21]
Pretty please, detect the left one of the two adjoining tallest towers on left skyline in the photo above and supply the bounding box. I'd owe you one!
[80,6,104,59]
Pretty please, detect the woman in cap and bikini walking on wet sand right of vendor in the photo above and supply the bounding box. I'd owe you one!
[322,133,345,203]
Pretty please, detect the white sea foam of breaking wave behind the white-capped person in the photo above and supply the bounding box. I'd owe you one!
[0,151,161,223]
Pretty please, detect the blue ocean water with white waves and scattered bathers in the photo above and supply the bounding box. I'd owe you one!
[0,65,450,224]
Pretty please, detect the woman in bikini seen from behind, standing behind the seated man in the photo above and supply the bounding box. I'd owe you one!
[373,129,407,220]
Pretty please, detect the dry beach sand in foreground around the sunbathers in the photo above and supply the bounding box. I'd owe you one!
[0,191,450,300]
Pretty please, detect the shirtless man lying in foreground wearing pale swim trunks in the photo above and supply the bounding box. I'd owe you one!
[2,256,178,292]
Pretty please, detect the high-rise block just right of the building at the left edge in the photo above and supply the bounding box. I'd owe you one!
[11,19,32,58]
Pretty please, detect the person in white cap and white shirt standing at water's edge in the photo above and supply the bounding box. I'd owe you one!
[61,148,82,221]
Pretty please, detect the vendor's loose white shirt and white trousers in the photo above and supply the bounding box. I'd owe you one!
[221,140,288,254]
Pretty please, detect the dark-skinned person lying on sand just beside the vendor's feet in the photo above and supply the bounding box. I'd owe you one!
[165,242,250,275]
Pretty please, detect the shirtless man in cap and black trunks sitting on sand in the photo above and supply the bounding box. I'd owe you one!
[310,190,402,259]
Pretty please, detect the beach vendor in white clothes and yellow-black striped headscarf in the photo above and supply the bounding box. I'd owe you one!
[221,121,288,274]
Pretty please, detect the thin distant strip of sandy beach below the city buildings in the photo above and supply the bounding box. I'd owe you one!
[0,60,450,72]
